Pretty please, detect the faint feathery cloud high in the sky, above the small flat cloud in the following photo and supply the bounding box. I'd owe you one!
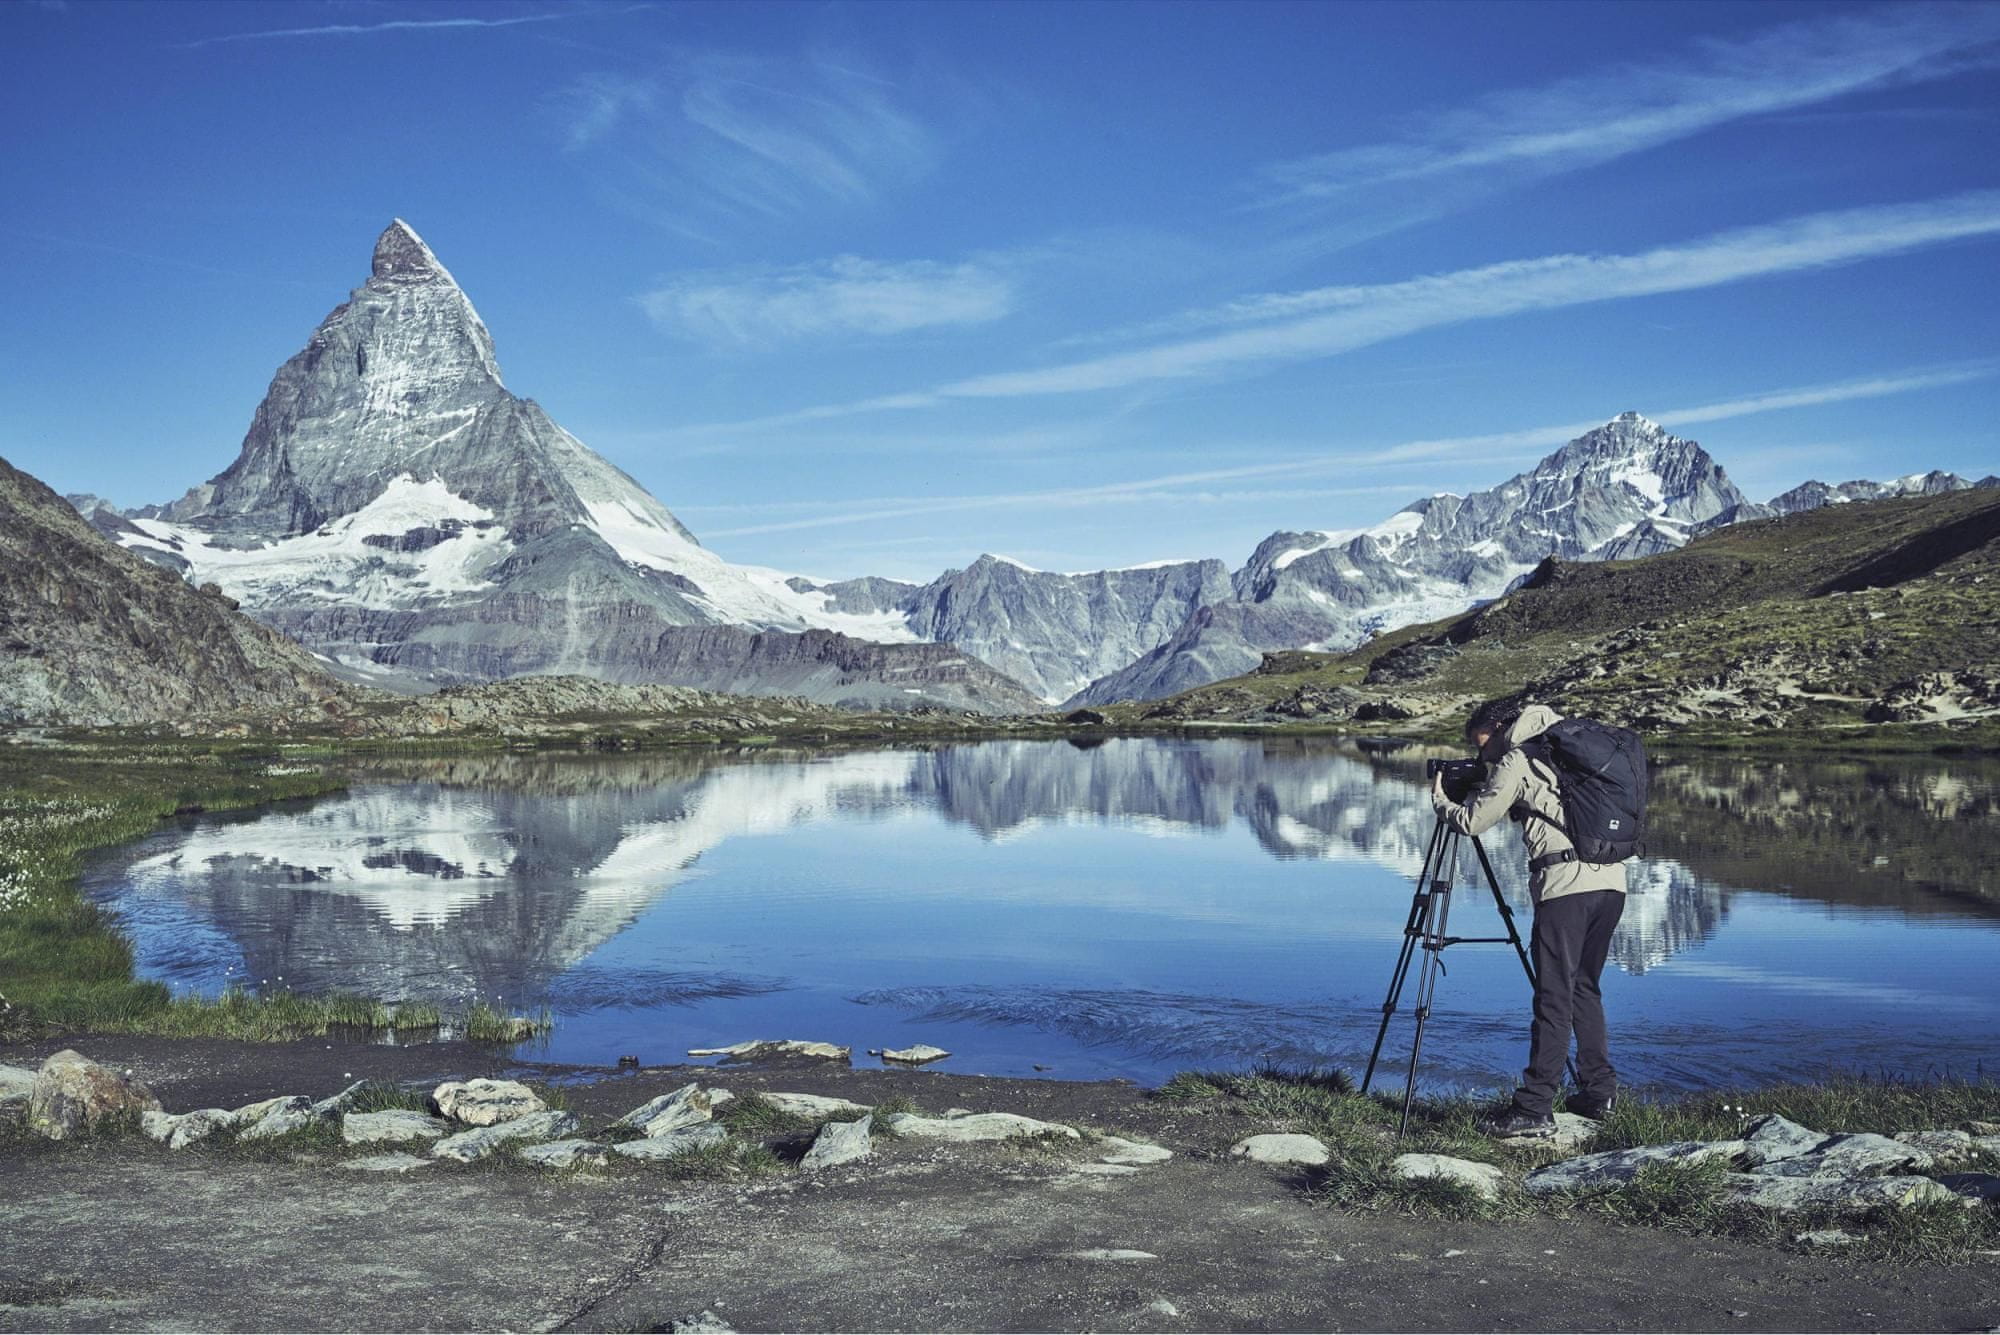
[546,50,938,236]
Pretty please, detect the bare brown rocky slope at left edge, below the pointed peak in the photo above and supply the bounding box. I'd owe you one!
[0,460,350,725]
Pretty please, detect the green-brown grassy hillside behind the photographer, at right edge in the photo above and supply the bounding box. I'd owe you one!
[1132,488,2000,735]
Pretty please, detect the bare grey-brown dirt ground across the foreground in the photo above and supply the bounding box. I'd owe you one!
[0,1039,2000,1331]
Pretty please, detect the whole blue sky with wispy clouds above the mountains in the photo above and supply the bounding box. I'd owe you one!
[0,0,2000,578]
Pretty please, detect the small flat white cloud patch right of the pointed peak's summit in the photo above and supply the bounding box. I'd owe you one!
[640,256,1014,346]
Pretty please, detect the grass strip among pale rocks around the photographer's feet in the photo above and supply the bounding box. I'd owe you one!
[1158,1069,2000,1263]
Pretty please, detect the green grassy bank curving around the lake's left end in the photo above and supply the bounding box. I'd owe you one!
[0,743,546,1041]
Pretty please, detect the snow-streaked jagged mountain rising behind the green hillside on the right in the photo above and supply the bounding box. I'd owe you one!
[1070,412,1748,703]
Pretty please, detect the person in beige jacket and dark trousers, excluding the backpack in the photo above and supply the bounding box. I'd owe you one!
[1432,701,1626,1135]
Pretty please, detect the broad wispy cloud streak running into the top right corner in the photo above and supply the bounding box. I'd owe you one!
[1260,4,2000,216]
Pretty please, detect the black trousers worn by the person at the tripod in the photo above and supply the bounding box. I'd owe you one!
[1514,889,1624,1115]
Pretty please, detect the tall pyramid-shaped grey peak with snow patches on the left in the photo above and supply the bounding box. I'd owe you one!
[94,220,1038,709]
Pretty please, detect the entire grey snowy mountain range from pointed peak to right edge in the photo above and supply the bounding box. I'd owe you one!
[70,220,1996,713]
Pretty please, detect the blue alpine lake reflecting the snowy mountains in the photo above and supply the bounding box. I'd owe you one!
[86,737,2000,1091]
